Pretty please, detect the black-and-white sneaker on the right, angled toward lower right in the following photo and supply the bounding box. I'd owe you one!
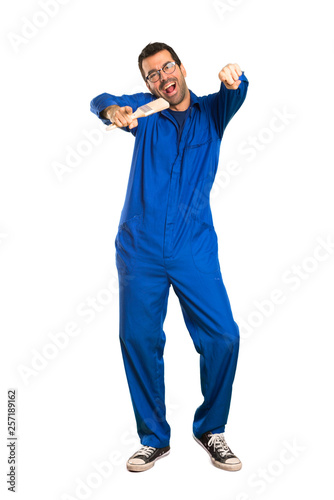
[194,432,242,471]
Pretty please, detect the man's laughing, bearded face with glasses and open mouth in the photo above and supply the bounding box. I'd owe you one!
[142,50,189,106]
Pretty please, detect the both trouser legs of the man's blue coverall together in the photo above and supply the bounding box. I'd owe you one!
[117,225,239,448]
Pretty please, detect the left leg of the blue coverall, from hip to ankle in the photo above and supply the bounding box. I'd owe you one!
[118,259,170,448]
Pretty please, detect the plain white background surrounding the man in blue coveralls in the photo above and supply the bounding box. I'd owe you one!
[0,0,334,500]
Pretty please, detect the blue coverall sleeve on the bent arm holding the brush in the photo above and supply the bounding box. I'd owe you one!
[90,92,153,135]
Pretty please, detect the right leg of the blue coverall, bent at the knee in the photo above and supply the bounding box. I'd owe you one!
[168,247,239,438]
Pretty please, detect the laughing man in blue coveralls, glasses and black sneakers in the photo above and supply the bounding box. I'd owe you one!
[91,43,248,471]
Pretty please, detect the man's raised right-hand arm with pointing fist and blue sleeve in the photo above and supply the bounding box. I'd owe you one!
[207,64,248,137]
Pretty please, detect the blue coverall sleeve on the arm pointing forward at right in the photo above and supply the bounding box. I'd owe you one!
[207,73,248,137]
